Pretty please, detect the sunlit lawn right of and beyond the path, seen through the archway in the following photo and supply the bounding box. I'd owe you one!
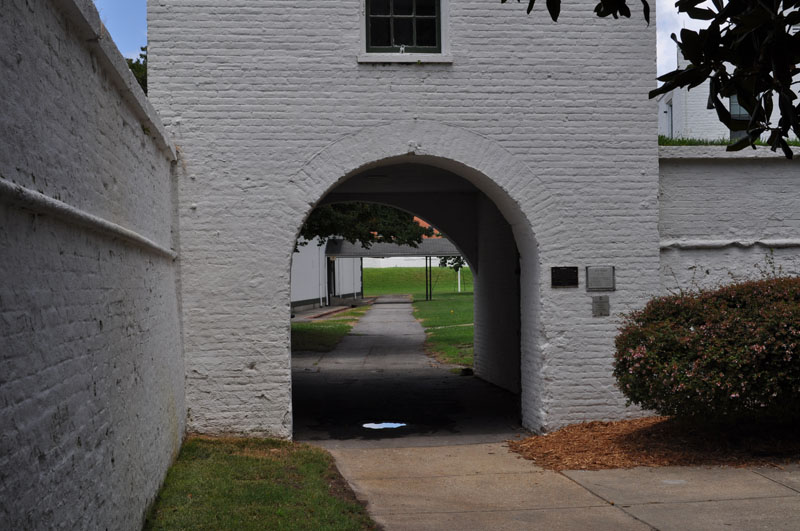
[364,267,475,367]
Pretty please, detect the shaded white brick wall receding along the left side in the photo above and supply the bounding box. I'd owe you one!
[0,0,185,529]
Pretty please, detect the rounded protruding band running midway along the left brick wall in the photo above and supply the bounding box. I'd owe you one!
[0,179,178,260]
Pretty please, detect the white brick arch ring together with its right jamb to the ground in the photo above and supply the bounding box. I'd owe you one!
[287,120,565,430]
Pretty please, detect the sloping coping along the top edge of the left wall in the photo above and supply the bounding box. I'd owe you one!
[51,0,178,161]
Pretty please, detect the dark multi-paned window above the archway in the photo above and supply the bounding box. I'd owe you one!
[366,0,442,54]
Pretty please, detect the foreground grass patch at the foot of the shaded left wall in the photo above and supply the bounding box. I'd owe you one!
[144,437,376,531]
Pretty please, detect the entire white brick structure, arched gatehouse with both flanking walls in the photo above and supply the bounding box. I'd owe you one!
[0,0,800,529]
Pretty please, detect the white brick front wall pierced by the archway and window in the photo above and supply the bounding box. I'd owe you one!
[148,0,659,436]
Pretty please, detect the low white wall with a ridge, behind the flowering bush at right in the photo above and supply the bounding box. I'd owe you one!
[659,147,800,290]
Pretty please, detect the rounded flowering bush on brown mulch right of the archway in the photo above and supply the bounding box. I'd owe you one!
[614,277,800,422]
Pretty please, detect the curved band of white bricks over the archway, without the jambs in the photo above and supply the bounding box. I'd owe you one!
[293,120,563,251]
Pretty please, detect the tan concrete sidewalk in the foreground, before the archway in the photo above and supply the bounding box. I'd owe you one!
[331,443,800,531]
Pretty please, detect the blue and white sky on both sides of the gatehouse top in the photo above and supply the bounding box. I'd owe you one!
[95,0,698,75]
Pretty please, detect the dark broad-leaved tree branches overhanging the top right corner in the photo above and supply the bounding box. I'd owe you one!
[510,0,800,158]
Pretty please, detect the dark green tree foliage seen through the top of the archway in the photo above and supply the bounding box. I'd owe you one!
[300,202,434,249]
